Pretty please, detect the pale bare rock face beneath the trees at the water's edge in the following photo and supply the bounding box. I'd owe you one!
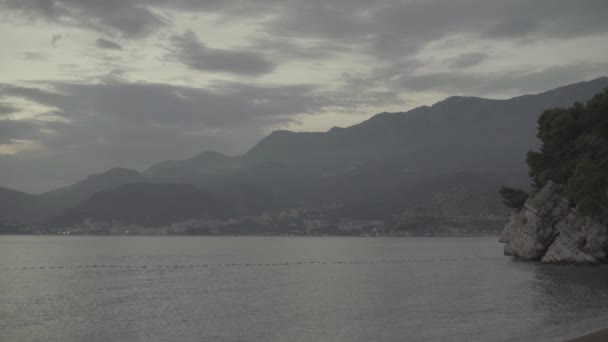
[500,182,608,264]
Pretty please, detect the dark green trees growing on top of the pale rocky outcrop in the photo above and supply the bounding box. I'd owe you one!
[500,89,608,218]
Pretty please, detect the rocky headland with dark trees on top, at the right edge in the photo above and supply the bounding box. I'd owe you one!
[500,90,608,264]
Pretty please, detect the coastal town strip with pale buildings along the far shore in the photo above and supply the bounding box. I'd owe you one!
[0,209,505,237]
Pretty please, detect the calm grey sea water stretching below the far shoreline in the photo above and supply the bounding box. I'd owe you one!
[0,236,608,341]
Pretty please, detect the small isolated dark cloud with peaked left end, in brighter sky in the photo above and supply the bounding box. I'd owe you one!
[169,31,275,75]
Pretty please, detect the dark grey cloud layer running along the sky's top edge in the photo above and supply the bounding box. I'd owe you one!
[0,0,608,57]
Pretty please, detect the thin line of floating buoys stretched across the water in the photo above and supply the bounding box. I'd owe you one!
[0,257,509,271]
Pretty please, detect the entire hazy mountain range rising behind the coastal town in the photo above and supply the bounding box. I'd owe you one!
[0,77,608,225]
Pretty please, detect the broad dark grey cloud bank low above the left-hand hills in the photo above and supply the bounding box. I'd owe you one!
[0,80,333,189]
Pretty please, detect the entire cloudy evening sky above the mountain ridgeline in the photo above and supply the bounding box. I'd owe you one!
[0,0,608,193]
